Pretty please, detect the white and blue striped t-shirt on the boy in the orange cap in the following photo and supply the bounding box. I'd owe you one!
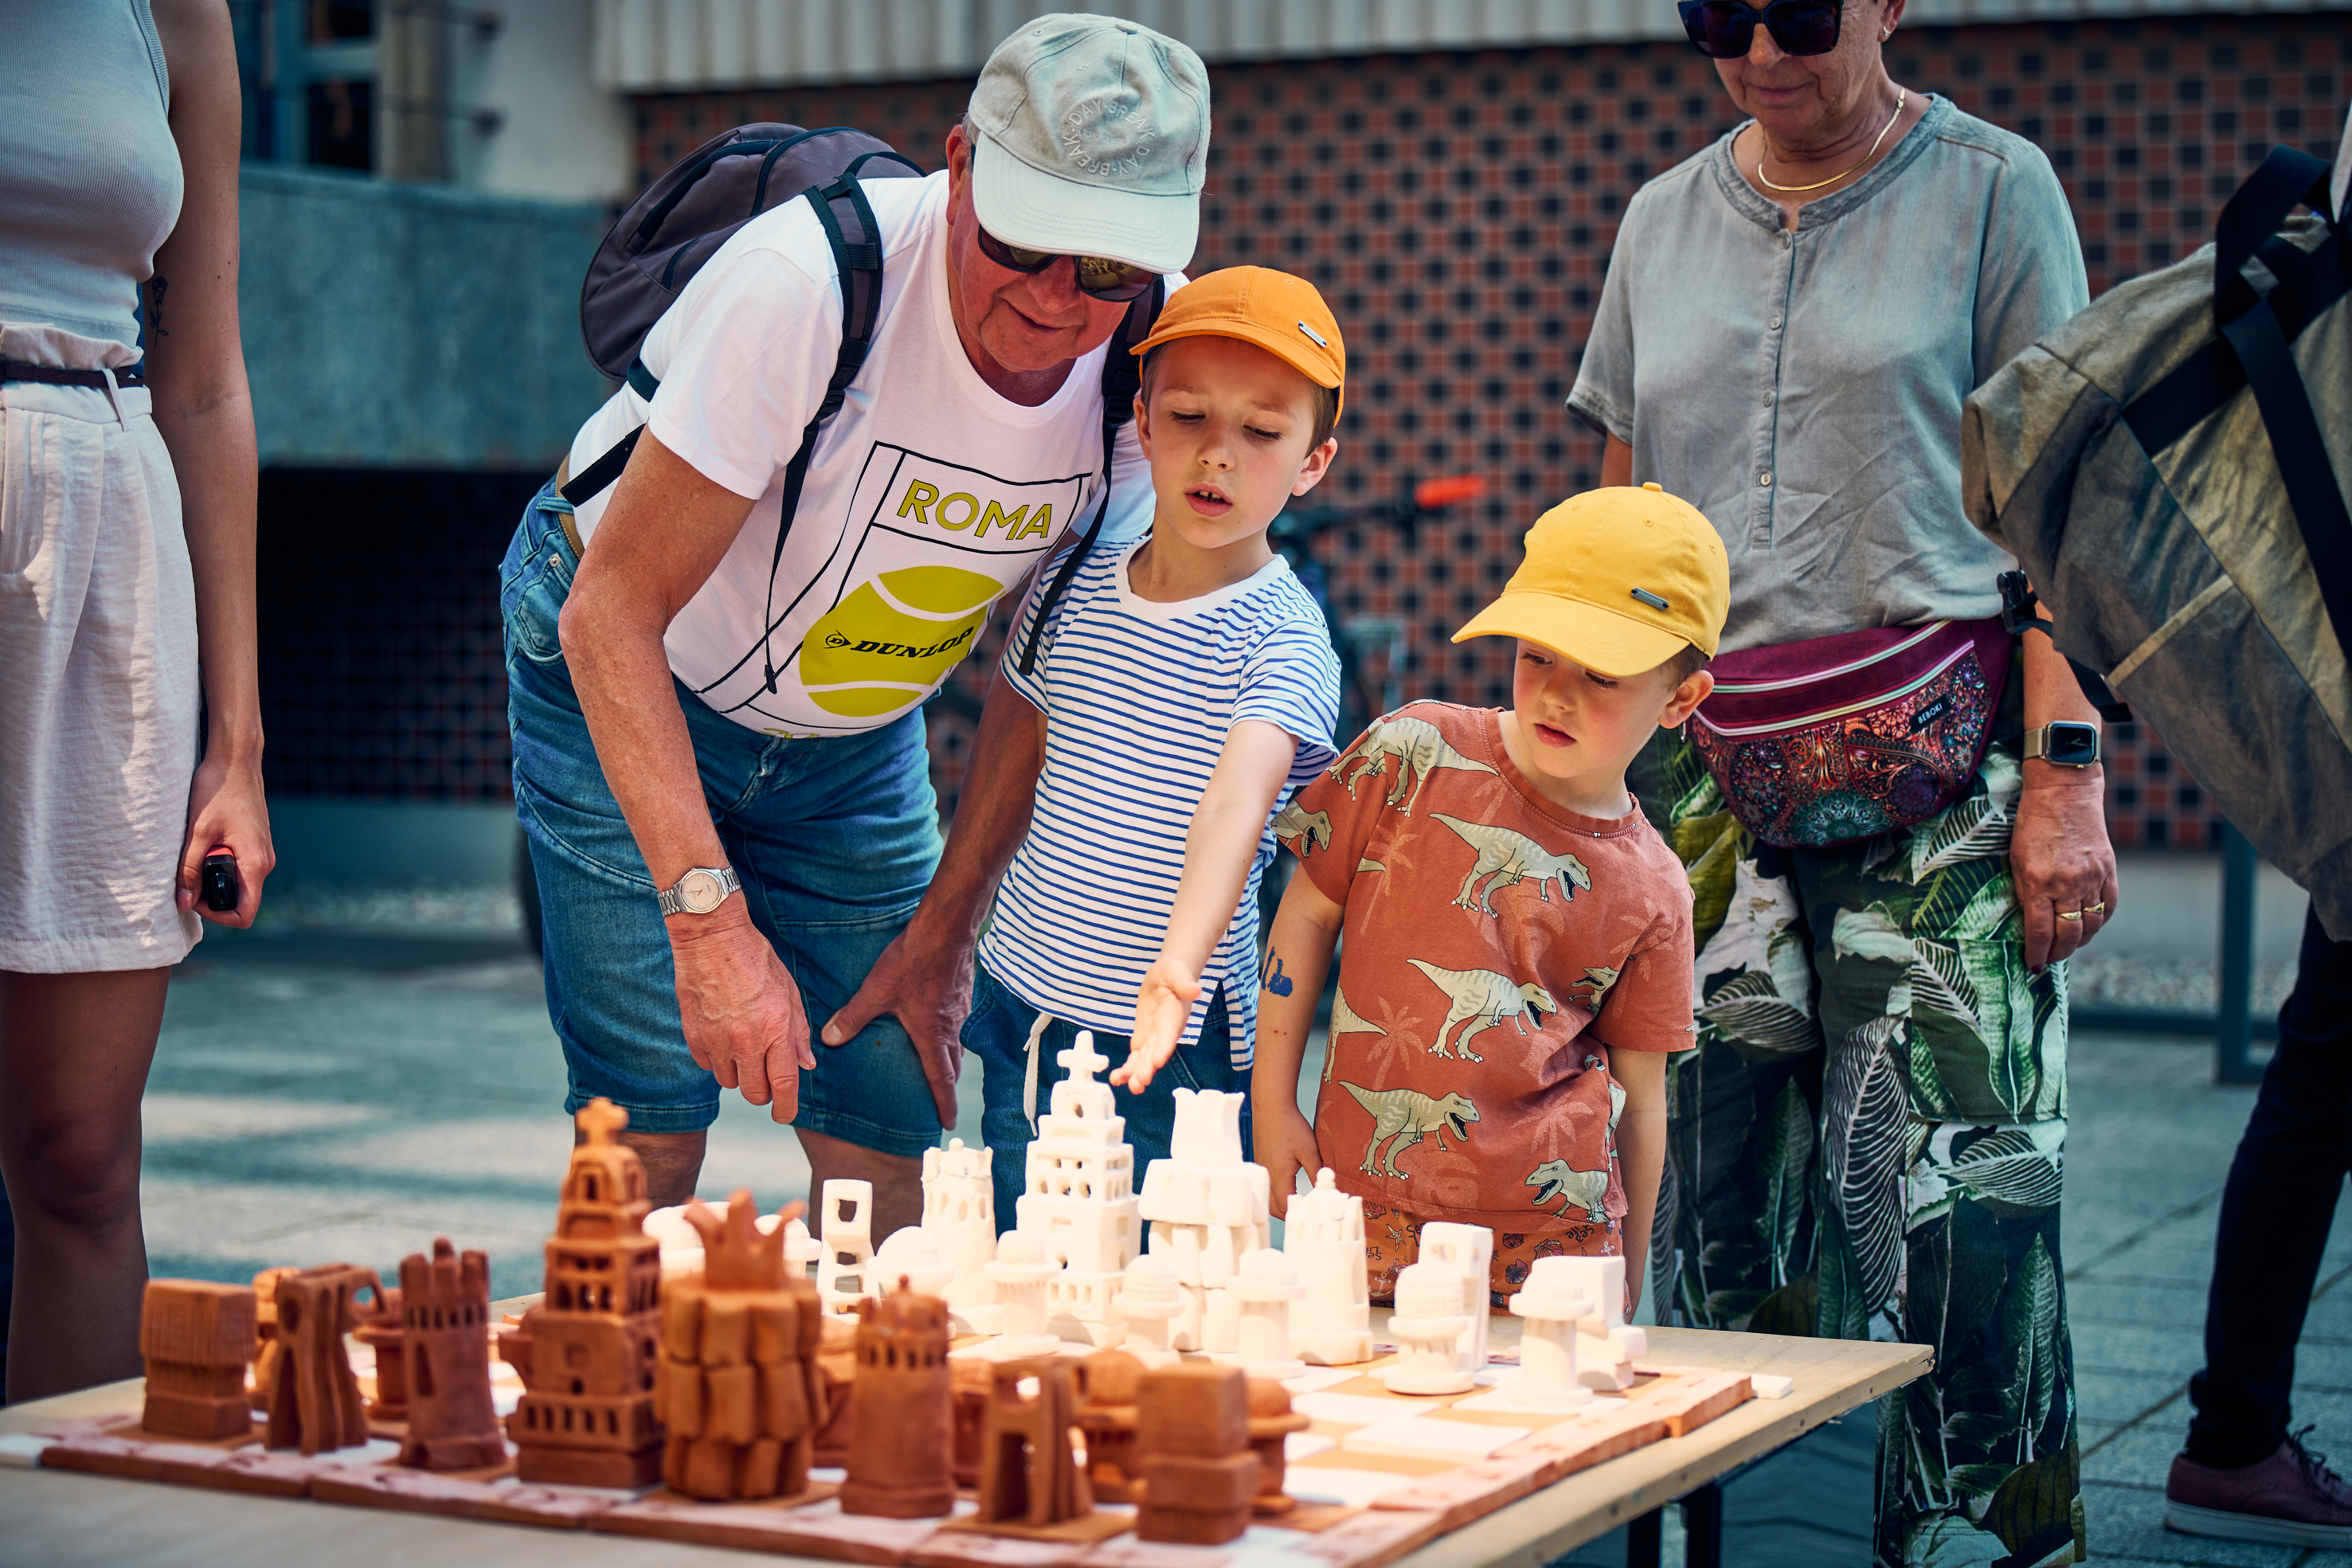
[980,538,1338,1067]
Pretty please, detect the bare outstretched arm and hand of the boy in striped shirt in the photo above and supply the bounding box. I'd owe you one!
[1110,719,1298,1091]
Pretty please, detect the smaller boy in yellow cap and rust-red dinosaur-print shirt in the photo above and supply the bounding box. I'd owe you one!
[1251,484,1731,1312]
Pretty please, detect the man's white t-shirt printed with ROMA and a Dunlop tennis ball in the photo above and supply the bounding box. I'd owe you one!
[572,174,1183,736]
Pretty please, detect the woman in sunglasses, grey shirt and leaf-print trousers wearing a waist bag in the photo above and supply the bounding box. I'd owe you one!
[1569,0,2117,1563]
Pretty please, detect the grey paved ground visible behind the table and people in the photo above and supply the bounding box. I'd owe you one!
[119,926,2352,1568]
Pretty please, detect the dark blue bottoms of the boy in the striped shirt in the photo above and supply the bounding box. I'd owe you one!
[965,964,1254,1234]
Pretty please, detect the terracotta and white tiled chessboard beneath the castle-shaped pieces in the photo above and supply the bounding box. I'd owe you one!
[0,1347,1752,1568]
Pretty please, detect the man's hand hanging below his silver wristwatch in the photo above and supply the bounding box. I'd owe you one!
[668,901,816,1121]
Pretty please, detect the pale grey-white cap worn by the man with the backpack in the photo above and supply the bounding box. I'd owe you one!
[972,14,1209,272]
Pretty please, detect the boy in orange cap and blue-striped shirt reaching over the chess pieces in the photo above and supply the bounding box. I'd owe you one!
[962,268,1348,1227]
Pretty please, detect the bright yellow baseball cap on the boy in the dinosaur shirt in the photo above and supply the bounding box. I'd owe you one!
[1454,484,1731,677]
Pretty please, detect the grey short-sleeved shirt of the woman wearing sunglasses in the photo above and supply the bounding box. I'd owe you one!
[1569,99,2091,651]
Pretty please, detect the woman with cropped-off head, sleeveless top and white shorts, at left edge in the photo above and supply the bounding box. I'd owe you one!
[0,0,273,1401]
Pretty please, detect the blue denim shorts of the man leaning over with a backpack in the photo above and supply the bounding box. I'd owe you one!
[499,484,938,1154]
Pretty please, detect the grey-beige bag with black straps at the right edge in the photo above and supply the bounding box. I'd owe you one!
[1962,148,2352,940]
